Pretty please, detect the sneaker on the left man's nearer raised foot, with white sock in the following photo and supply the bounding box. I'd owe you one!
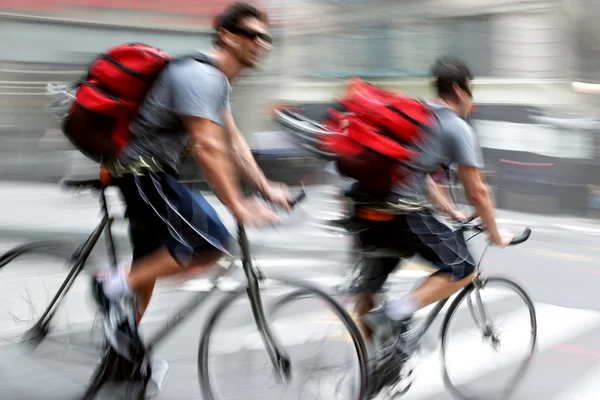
[91,277,143,361]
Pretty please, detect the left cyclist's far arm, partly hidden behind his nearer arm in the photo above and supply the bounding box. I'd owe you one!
[225,109,269,194]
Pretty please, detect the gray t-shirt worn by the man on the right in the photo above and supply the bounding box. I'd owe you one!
[393,102,484,201]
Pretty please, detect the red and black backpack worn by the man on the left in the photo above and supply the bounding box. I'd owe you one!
[62,43,210,163]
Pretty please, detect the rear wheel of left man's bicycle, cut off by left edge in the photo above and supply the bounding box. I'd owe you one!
[0,241,104,398]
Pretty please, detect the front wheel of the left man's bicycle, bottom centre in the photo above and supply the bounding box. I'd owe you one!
[198,279,367,400]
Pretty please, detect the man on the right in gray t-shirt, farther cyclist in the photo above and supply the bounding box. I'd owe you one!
[354,58,513,395]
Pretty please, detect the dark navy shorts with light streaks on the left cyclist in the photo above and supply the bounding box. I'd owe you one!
[115,172,231,267]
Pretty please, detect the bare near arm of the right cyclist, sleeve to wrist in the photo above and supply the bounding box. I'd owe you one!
[458,165,501,242]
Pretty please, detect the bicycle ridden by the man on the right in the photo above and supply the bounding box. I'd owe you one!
[298,183,537,400]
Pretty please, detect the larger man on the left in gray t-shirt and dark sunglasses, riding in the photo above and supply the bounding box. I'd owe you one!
[92,2,291,359]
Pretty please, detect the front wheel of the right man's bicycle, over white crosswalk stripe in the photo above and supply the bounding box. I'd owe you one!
[442,277,537,400]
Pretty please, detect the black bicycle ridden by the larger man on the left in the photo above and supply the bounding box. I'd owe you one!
[0,179,367,400]
